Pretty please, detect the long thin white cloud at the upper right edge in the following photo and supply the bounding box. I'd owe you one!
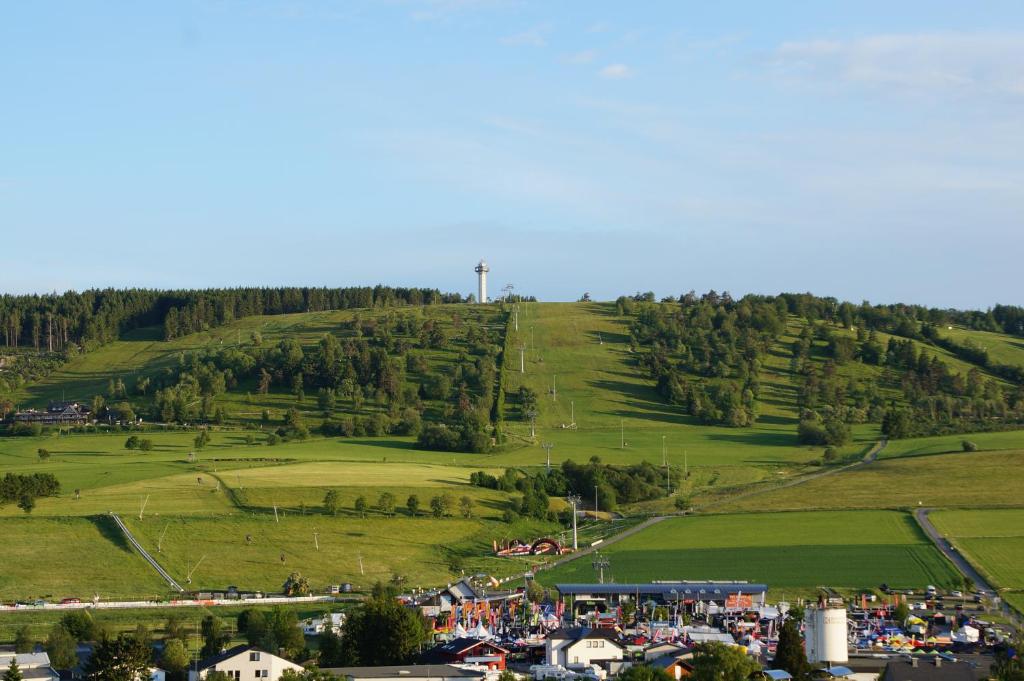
[770,32,1024,94]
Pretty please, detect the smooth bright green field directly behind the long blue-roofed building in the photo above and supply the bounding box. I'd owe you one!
[539,511,954,593]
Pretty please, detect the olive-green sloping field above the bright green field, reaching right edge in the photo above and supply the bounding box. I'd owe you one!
[715,451,1024,511]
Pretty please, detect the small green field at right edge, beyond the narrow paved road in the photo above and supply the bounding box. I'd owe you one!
[930,509,1024,590]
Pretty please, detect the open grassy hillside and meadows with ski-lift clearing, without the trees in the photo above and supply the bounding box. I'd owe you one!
[6,303,1024,598]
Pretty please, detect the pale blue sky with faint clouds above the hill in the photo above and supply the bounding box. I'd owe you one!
[0,0,1024,308]
